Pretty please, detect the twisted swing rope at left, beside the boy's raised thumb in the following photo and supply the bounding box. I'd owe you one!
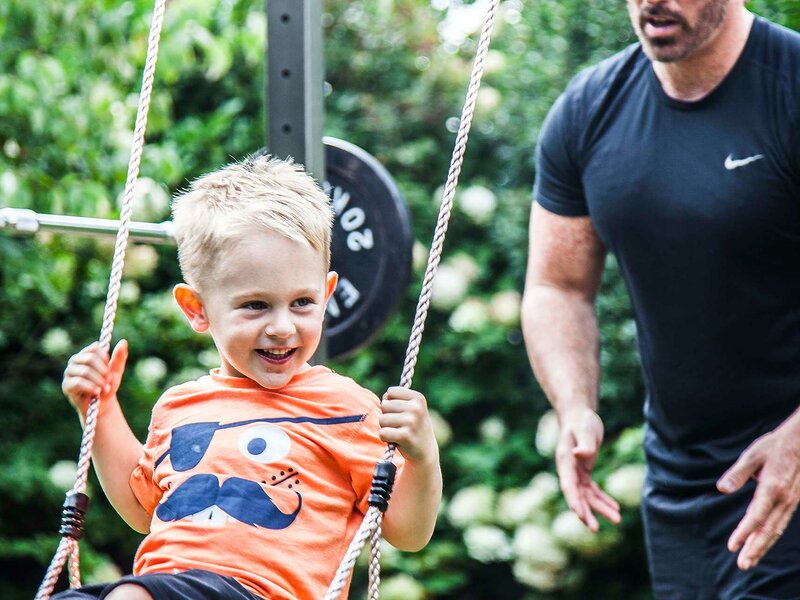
[35,0,166,600]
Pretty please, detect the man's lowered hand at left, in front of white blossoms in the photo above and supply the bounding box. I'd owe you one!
[556,408,620,532]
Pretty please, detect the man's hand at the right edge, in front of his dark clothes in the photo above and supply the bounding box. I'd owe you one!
[717,420,800,570]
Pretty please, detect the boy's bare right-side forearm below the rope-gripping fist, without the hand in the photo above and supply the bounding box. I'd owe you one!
[383,456,442,552]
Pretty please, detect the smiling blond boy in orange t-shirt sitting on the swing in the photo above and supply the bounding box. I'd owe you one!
[57,156,442,600]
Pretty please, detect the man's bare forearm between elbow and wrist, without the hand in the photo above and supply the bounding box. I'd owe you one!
[522,284,600,417]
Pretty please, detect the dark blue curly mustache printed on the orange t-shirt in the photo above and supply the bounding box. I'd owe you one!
[156,474,303,529]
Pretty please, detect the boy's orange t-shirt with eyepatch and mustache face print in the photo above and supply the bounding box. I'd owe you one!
[130,366,402,600]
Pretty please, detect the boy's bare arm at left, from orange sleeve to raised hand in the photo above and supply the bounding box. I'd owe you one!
[62,340,150,533]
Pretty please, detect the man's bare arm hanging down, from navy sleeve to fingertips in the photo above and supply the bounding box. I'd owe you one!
[522,203,620,531]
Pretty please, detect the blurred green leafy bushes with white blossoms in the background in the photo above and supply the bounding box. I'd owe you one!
[0,0,800,600]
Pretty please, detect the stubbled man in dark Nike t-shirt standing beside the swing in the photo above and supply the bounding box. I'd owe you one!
[523,0,800,600]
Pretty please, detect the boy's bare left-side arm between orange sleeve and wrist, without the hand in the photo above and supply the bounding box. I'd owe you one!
[80,399,150,533]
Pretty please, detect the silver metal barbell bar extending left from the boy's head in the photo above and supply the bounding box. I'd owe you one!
[0,208,175,244]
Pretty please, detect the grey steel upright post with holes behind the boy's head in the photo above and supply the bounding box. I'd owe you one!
[265,0,328,364]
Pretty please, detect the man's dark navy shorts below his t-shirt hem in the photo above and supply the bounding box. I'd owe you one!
[642,482,800,600]
